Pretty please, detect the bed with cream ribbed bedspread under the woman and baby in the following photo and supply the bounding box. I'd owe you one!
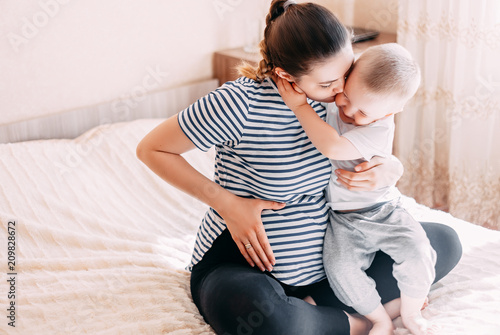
[0,119,500,335]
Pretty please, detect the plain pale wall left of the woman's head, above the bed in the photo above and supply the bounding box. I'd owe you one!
[0,0,267,125]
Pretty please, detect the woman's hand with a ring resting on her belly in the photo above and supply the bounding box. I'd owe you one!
[215,195,285,271]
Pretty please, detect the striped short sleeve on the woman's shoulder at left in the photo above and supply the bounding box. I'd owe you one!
[177,78,248,151]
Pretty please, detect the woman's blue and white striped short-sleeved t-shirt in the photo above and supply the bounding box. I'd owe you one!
[178,77,331,285]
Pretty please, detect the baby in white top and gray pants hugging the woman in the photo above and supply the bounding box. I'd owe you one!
[278,43,436,335]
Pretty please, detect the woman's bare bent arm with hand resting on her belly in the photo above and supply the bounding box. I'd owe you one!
[137,115,284,271]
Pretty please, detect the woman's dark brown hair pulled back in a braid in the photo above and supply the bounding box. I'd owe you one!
[238,0,350,81]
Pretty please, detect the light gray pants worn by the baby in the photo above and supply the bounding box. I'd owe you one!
[323,200,436,315]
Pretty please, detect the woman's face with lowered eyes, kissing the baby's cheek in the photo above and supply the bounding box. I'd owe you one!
[292,43,354,102]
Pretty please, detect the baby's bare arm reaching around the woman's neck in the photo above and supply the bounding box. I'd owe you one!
[278,78,362,160]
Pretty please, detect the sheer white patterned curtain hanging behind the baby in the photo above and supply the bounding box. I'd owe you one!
[394,0,500,229]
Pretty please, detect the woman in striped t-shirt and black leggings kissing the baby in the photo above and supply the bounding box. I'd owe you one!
[137,1,460,334]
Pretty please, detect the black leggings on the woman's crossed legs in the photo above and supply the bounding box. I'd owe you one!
[191,222,462,335]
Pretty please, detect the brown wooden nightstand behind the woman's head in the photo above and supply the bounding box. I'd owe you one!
[213,33,396,85]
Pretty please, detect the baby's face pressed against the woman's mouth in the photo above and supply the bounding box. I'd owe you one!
[335,68,406,126]
